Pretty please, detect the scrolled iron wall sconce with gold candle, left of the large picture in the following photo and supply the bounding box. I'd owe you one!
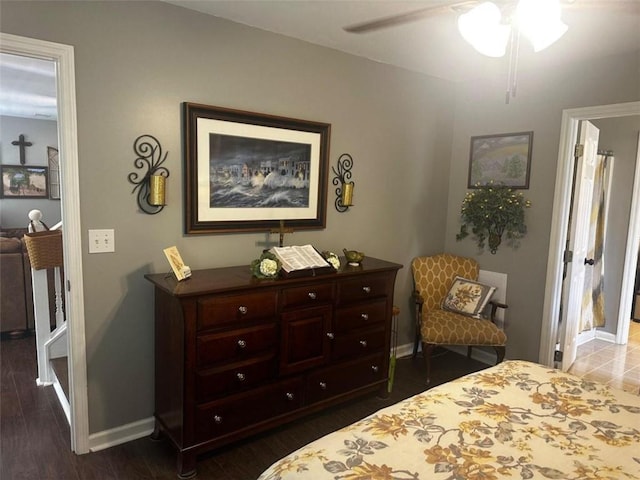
[127,135,169,215]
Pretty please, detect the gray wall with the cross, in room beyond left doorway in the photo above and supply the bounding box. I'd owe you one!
[0,116,61,227]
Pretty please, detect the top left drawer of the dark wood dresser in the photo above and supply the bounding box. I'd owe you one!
[198,290,277,329]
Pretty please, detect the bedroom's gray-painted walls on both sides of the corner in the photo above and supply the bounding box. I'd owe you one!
[0,1,640,433]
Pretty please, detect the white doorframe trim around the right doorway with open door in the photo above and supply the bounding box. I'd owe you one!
[538,102,640,367]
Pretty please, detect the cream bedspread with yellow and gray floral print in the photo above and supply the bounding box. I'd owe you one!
[258,361,640,480]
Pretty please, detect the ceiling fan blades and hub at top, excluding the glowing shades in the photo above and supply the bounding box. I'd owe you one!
[344,0,638,33]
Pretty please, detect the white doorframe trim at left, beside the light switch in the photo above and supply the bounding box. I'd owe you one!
[0,32,89,454]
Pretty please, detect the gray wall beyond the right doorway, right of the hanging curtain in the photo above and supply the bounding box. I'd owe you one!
[593,116,640,335]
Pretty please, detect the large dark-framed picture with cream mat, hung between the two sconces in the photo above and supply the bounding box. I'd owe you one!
[183,102,331,234]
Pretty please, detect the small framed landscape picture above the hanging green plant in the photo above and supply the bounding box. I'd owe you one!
[467,132,533,189]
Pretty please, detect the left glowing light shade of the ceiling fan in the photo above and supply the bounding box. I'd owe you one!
[458,2,511,57]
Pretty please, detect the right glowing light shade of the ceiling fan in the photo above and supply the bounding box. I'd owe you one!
[515,0,569,52]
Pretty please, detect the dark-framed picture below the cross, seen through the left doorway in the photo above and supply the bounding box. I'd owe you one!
[0,165,49,199]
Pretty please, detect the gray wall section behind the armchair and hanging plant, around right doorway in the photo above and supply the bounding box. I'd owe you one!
[445,52,640,360]
